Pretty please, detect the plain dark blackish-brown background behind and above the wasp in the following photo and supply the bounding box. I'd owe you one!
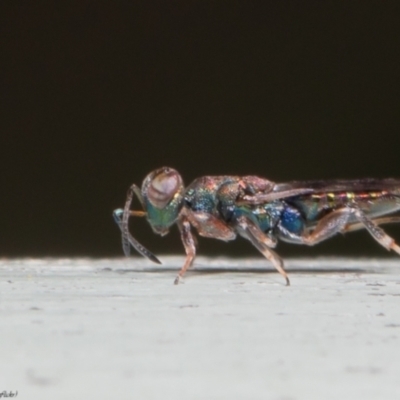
[0,0,400,257]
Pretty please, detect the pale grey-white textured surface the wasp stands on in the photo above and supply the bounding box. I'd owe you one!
[0,257,400,400]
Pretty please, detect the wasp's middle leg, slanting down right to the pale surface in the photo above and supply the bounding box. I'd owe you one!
[238,217,290,286]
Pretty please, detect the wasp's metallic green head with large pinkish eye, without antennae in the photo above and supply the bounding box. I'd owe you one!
[142,167,184,235]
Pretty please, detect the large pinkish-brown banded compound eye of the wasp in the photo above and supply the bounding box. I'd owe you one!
[143,168,182,208]
